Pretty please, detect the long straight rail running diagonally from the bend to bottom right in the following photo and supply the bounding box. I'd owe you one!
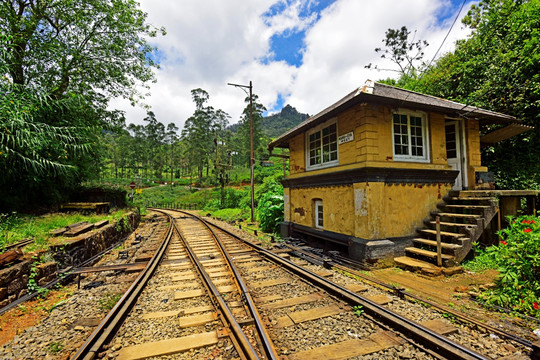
[201,215,488,360]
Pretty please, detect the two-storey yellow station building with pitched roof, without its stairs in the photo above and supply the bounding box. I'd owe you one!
[268,81,516,260]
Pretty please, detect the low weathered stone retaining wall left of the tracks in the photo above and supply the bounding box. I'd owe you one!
[0,212,141,308]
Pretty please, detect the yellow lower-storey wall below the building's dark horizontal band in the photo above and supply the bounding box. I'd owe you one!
[285,182,451,239]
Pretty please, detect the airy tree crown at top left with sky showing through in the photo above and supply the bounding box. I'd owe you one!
[0,0,164,100]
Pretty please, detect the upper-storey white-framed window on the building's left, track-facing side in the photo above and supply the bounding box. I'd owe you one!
[306,121,338,170]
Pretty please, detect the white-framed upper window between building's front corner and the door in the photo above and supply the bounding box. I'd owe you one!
[392,110,429,162]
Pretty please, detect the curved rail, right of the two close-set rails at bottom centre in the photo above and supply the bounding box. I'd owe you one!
[184,210,279,360]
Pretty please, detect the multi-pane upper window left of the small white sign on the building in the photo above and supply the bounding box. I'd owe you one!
[308,124,337,166]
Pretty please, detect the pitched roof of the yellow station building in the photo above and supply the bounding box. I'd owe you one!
[268,80,517,150]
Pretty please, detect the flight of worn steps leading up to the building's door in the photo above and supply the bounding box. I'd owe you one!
[394,191,498,268]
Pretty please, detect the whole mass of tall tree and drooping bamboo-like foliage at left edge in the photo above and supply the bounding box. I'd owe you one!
[0,0,165,209]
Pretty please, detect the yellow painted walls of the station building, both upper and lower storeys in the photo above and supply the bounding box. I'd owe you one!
[285,100,485,239]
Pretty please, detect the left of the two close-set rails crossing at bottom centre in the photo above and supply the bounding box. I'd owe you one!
[162,209,259,360]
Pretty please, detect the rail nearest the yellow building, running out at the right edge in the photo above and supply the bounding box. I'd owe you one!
[284,244,540,352]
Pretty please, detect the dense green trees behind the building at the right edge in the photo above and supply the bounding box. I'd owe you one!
[406,0,540,189]
